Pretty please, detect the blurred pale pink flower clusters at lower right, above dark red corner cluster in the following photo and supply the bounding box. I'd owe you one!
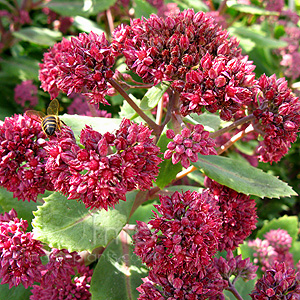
[248,229,294,271]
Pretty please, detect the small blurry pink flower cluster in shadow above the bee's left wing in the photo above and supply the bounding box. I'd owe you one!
[14,80,38,107]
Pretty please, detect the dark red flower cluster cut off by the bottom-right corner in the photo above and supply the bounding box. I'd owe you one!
[250,262,300,300]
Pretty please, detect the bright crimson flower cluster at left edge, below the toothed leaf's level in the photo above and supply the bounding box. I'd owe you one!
[0,209,45,288]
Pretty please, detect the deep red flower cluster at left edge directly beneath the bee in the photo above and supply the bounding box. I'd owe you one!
[0,115,53,201]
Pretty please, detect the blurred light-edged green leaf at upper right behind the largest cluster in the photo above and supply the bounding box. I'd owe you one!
[228,25,287,49]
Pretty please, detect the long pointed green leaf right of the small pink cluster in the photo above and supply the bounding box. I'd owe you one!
[192,154,297,198]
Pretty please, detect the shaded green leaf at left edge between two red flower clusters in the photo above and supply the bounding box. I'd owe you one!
[0,187,41,231]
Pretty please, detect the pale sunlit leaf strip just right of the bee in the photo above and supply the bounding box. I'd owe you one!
[59,114,122,138]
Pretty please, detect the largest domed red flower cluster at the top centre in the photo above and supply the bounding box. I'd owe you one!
[112,9,255,120]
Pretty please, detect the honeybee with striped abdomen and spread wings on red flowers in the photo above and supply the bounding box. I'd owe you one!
[26,99,66,137]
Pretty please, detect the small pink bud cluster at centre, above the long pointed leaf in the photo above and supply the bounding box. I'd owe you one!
[164,124,217,168]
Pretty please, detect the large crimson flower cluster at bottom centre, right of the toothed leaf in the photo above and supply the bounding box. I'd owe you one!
[133,191,226,299]
